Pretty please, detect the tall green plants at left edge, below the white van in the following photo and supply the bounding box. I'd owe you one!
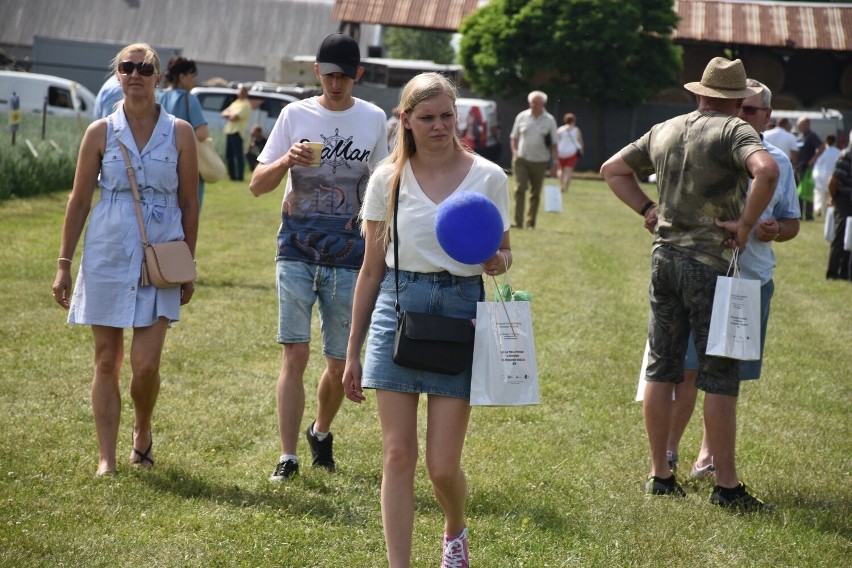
[0,113,88,200]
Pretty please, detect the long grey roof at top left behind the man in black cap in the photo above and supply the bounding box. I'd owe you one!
[0,0,366,67]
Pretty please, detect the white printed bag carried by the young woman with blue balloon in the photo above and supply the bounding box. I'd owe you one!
[470,302,539,406]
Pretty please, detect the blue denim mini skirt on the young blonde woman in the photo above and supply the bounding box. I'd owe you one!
[361,269,485,400]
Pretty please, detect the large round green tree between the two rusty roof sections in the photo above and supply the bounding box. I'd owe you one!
[459,0,681,106]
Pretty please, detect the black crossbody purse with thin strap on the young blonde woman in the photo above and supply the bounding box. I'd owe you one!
[393,182,474,375]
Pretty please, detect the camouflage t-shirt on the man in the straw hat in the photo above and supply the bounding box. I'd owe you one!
[621,110,764,271]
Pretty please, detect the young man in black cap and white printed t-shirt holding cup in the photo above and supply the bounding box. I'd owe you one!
[250,33,387,481]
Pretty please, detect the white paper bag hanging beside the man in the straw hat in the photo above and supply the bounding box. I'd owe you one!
[706,249,760,361]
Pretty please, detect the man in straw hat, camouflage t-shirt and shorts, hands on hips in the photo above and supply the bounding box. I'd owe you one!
[601,57,779,510]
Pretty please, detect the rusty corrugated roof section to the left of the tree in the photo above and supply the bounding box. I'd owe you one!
[331,0,480,31]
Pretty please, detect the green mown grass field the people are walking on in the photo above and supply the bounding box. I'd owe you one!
[0,175,852,568]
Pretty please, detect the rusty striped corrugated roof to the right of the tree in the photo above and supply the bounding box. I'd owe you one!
[674,0,852,51]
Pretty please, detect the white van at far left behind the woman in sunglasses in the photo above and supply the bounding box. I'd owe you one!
[0,71,95,121]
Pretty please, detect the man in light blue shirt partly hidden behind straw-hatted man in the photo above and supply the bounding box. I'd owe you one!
[667,79,801,488]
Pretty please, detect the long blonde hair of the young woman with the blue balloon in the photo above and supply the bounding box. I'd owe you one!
[382,72,470,245]
